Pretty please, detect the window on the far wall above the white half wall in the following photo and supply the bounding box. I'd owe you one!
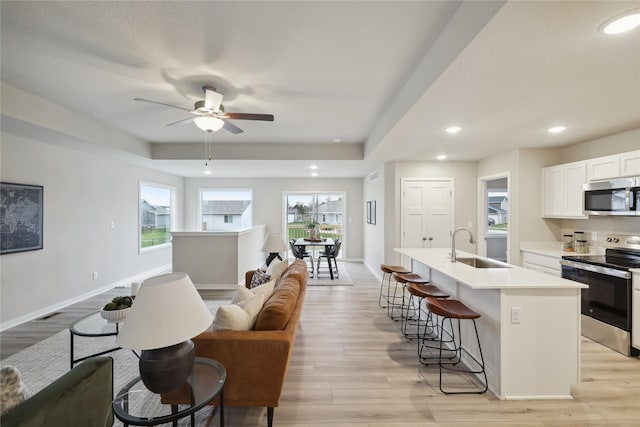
[198,188,253,231]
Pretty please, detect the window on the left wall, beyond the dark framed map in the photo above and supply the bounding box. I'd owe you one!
[139,182,175,252]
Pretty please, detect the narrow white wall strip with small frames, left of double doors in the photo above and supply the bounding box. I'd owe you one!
[362,165,382,274]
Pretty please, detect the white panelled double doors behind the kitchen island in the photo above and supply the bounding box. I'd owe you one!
[401,180,453,262]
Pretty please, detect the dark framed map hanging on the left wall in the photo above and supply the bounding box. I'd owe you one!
[0,182,44,255]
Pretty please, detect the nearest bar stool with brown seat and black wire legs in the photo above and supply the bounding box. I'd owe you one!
[421,297,489,394]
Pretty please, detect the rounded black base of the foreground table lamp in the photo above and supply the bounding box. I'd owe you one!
[139,340,196,393]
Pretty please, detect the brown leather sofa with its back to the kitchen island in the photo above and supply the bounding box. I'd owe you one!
[162,260,309,427]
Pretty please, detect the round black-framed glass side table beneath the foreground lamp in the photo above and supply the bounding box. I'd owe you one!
[112,357,227,427]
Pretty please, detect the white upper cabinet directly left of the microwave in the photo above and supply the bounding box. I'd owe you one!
[542,162,586,218]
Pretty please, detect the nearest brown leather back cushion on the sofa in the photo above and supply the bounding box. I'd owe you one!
[254,273,300,331]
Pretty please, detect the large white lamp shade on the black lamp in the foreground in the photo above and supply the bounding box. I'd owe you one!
[116,273,213,350]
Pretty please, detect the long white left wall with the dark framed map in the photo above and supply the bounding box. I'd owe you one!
[0,132,182,330]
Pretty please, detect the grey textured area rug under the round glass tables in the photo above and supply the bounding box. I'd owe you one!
[0,300,229,426]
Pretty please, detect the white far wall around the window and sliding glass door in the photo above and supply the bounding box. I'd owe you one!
[184,178,365,260]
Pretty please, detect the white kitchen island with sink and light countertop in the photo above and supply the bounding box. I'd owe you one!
[396,248,586,399]
